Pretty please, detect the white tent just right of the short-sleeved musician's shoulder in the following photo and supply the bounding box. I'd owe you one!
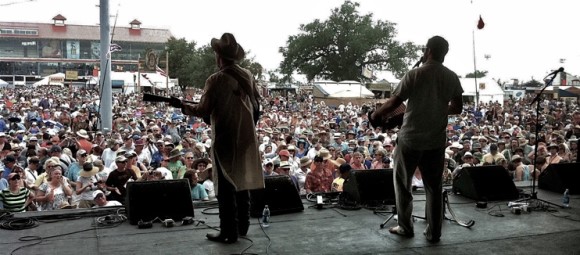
[459,78,505,105]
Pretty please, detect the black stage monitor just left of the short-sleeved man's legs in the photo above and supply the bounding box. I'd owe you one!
[341,168,395,205]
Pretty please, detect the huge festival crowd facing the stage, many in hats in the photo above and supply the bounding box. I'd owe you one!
[0,80,580,212]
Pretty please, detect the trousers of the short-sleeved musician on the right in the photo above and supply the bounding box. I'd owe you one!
[393,144,445,239]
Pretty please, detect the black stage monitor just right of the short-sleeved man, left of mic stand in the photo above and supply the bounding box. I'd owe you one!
[453,165,519,201]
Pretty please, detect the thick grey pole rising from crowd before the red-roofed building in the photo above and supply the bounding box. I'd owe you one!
[99,0,113,130]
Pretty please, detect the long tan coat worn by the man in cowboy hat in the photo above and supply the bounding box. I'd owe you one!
[183,65,264,191]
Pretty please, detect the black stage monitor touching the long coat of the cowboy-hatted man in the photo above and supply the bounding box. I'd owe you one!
[250,175,304,217]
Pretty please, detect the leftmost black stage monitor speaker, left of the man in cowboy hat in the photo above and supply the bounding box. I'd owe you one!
[125,179,194,225]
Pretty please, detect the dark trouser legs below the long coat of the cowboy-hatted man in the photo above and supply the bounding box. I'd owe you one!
[215,167,250,236]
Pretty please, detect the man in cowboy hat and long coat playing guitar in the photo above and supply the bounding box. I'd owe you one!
[170,33,264,243]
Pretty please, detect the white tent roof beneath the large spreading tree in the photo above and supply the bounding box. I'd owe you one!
[314,81,375,98]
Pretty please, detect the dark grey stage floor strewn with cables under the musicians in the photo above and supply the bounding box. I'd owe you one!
[0,187,580,255]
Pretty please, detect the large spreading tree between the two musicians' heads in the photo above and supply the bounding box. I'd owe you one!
[279,1,420,81]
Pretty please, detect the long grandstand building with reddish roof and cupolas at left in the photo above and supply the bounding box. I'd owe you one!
[0,14,172,84]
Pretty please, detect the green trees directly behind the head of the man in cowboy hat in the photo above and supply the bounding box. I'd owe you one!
[159,37,263,90]
